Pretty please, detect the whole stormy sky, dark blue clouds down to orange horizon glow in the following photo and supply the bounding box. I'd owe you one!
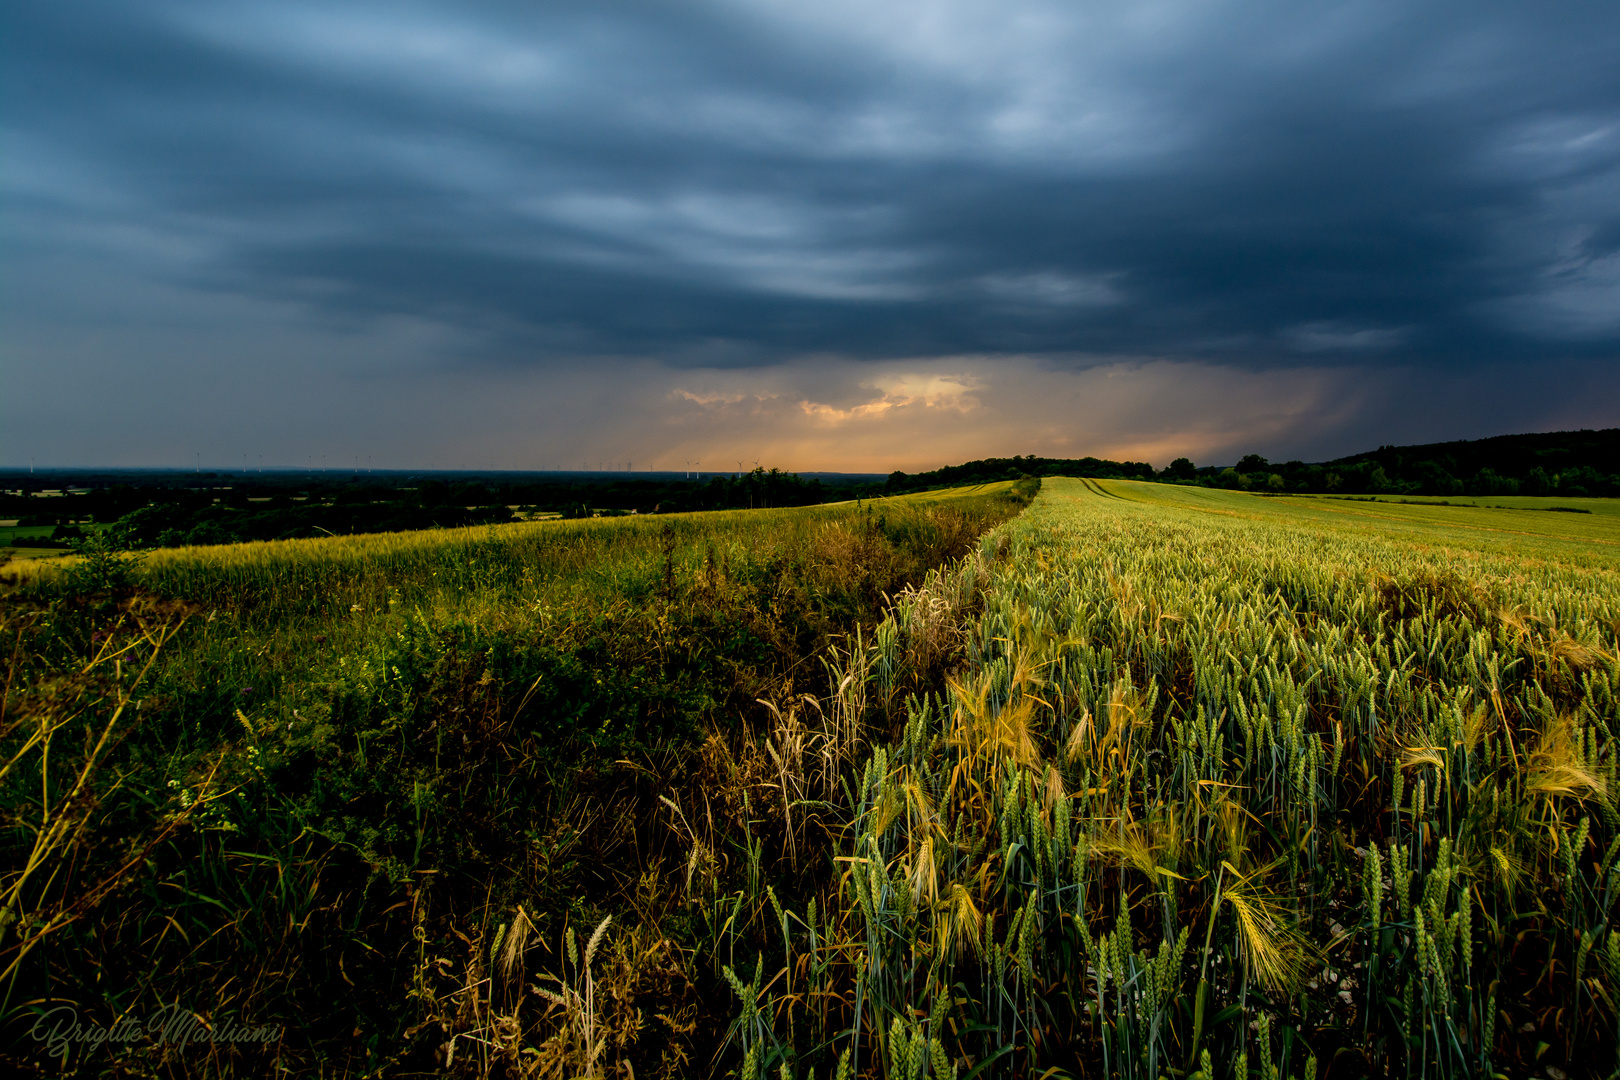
[0,0,1620,471]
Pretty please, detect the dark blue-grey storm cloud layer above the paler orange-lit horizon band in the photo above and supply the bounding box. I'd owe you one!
[3,0,1620,366]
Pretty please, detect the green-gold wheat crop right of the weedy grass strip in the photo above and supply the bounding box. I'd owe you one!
[683,481,1620,1080]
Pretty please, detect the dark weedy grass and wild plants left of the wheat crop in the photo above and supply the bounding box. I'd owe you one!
[0,486,1034,1077]
